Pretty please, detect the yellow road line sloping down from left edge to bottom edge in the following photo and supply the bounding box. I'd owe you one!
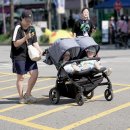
[0,115,56,130]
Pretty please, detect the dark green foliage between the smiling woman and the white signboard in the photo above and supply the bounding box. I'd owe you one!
[92,29,102,44]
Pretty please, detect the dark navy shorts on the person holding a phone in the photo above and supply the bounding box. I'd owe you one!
[13,60,38,75]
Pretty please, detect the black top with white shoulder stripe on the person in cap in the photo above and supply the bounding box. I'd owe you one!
[10,25,37,61]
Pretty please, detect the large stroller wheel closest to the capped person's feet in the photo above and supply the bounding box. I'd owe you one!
[49,88,60,104]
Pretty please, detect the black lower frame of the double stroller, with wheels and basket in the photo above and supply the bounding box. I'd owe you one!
[49,58,113,106]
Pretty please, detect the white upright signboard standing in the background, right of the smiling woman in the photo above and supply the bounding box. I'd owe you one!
[102,20,109,43]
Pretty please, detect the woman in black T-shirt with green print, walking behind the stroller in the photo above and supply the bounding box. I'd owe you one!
[72,7,96,37]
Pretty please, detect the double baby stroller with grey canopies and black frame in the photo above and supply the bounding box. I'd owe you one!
[45,37,113,106]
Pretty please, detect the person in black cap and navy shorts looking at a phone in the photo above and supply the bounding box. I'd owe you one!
[10,10,42,104]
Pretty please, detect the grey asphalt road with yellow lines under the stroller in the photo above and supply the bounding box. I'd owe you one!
[0,46,130,130]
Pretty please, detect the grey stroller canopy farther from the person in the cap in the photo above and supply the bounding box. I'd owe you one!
[76,36,100,58]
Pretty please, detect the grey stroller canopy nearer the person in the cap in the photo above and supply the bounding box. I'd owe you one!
[48,38,80,65]
